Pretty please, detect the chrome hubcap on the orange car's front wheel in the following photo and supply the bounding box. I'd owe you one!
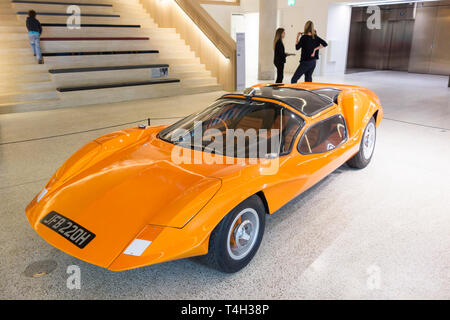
[227,208,259,260]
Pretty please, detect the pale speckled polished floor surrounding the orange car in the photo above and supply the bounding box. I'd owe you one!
[0,71,450,299]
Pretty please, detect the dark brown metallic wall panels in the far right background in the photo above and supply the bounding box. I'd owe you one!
[347,0,450,75]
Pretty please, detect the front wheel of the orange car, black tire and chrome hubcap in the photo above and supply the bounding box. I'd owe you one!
[201,195,266,273]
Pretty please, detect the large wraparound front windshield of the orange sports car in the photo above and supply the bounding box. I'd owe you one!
[159,99,304,158]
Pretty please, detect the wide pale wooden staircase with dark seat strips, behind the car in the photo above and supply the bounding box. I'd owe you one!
[0,0,222,114]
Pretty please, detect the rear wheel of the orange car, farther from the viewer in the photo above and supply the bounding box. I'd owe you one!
[347,118,377,169]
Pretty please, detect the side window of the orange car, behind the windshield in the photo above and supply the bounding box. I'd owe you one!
[298,115,347,154]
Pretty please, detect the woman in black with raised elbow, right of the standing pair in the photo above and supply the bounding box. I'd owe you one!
[291,21,328,83]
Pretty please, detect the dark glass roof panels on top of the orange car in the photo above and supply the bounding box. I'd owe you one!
[222,85,341,117]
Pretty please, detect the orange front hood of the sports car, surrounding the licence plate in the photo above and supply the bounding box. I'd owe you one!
[26,130,221,267]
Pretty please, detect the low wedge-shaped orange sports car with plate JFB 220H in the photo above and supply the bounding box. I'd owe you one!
[26,83,383,273]
